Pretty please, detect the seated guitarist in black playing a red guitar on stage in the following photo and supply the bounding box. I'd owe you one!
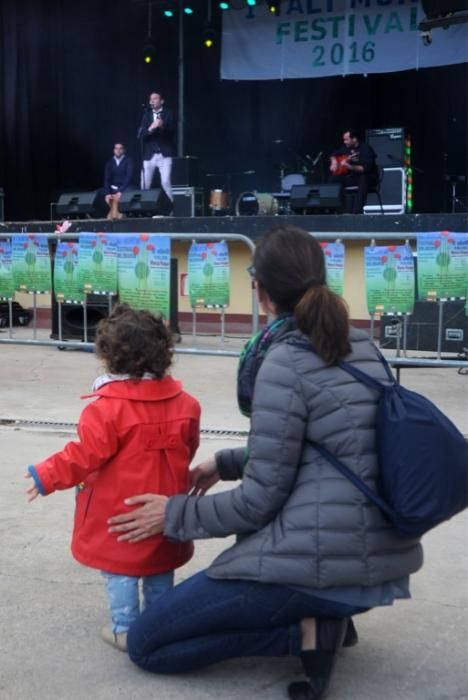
[329,129,378,214]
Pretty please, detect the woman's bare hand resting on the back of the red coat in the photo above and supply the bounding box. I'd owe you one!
[107,493,168,542]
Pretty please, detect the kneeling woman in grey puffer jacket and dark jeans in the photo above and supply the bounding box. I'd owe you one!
[108,227,422,700]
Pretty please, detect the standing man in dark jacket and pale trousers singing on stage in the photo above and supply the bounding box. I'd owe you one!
[138,92,175,201]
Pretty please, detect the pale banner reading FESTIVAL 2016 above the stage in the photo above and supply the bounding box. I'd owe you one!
[221,0,468,80]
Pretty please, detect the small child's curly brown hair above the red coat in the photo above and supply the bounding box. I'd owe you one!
[96,304,174,379]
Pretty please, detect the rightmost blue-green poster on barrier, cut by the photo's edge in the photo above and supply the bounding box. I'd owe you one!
[418,231,468,301]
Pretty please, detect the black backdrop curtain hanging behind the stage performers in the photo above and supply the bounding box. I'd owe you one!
[0,0,467,221]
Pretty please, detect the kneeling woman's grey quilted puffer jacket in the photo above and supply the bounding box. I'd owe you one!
[165,329,423,588]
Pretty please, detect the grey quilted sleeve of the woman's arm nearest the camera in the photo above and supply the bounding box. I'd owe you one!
[165,350,307,541]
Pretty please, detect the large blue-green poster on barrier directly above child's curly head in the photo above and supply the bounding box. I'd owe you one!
[119,233,171,318]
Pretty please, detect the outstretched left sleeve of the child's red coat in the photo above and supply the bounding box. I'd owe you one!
[30,399,119,496]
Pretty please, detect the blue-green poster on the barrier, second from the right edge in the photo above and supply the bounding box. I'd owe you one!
[364,245,415,316]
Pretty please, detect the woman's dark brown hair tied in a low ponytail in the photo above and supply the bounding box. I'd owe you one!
[254,226,351,364]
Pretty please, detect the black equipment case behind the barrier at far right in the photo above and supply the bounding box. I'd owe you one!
[380,301,468,353]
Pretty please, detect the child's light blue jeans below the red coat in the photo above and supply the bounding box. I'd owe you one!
[101,571,174,633]
